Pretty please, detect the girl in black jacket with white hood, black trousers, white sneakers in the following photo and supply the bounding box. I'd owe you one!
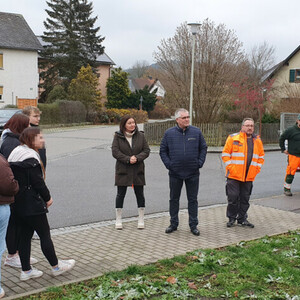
[8,127,75,280]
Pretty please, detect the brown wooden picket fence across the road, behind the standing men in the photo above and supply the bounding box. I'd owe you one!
[144,120,279,147]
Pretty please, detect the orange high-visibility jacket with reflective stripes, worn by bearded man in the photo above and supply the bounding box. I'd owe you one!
[222,131,265,182]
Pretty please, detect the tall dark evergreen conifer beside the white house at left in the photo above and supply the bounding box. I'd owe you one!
[40,0,104,101]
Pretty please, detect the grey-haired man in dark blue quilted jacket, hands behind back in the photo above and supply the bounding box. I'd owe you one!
[159,108,207,236]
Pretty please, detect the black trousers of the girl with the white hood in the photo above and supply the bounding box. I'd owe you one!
[19,214,58,271]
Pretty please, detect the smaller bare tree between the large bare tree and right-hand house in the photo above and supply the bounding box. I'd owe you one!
[248,41,275,83]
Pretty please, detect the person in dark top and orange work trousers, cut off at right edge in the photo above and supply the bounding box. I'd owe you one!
[279,114,300,196]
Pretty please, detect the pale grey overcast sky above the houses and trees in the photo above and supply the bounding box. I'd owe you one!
[0,0,300,69]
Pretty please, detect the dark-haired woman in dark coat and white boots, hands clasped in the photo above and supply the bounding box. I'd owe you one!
[112,115,150,229]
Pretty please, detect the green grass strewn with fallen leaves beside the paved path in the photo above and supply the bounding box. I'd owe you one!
[23,231,300,300]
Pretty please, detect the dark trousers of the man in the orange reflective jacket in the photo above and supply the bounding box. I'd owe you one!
[226,178,253,222]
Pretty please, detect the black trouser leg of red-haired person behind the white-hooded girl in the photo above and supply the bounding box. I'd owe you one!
[5,205,19,255]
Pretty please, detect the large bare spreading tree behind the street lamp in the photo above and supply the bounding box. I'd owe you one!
[154,19,247,122]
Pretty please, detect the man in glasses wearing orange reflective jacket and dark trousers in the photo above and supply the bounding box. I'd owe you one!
[222,118,265,228]
